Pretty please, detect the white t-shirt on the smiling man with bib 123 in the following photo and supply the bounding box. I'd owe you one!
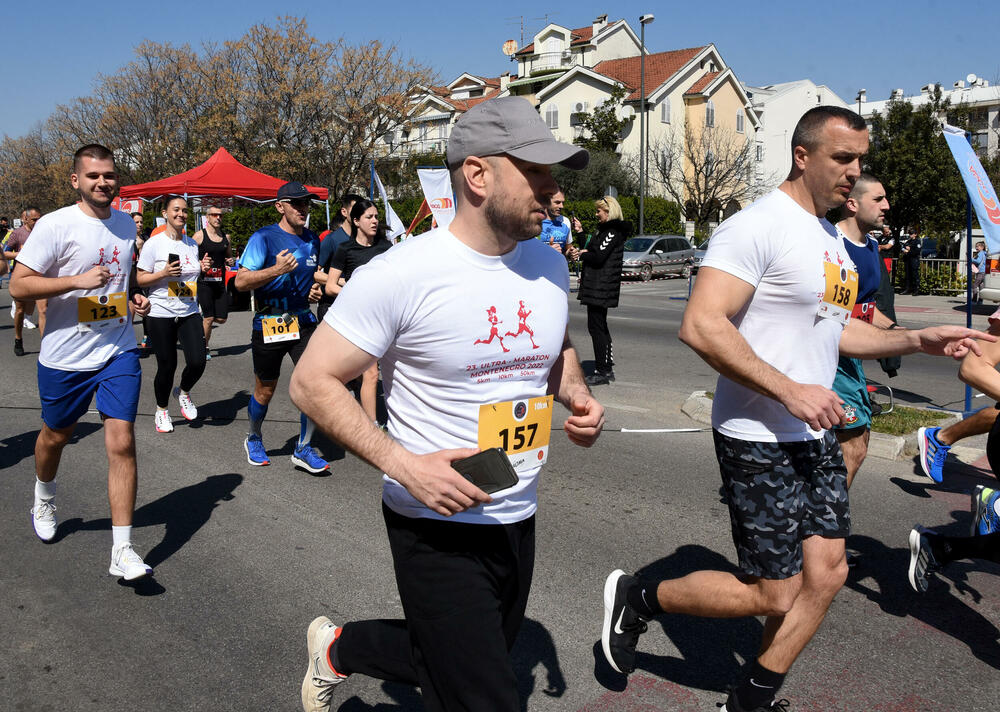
[17,205,135,371]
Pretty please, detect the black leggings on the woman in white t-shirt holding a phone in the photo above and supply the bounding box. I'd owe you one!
[146,314,205,408]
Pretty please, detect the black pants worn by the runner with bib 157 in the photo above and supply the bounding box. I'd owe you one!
[337,504,535,712]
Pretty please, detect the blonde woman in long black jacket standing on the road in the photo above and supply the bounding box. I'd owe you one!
[573,195,632,386]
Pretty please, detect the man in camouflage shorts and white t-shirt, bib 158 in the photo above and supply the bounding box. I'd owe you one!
[601,106,993,712]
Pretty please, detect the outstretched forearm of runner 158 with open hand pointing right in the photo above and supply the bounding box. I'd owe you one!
[840,319,996,359]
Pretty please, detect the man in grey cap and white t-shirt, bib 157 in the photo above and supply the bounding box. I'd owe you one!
[291,97,604,712]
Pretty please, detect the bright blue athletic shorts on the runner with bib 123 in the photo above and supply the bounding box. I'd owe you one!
[38,349,142,430]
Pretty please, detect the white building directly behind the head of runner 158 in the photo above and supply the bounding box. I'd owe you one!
[745,79,852,188]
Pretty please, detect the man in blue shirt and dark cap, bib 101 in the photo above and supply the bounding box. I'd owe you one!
[235,182,329,473]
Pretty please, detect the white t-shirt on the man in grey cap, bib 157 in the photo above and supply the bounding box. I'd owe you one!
[325,228,569,524]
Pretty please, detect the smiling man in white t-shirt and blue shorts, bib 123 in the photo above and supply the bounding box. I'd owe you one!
[10,144,152,580]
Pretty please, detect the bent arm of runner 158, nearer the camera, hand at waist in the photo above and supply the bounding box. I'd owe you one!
[678,267,848,430]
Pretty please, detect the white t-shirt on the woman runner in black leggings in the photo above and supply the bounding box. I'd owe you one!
[137,232,201,318]
